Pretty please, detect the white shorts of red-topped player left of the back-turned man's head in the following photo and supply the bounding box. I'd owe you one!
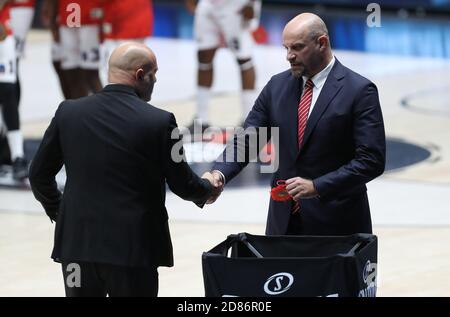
[59,25,100,70]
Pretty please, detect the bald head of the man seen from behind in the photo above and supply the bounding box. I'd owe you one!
[108,42,158,101]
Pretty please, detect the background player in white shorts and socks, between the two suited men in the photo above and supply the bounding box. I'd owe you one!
[186,0,261,129]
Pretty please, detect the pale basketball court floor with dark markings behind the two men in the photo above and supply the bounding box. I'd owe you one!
[0,32,450,297]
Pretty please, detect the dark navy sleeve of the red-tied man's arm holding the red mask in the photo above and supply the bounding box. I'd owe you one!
[313,83,386,201]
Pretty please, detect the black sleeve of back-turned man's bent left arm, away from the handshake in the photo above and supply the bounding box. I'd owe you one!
[30,106,63,221]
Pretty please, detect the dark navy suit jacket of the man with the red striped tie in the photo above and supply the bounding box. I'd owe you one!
[214,60,386,235]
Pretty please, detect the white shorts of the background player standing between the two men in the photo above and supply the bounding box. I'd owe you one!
[194,1,254,59]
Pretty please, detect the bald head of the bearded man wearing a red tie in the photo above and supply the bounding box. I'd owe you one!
[283,13,333,78]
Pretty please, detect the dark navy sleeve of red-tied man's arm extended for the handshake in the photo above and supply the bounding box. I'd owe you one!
[212,77,271,183]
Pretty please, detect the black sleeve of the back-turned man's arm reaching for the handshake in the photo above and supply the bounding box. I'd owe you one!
[165,114,212,205]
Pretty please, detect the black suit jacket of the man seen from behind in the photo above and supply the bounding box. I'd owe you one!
[30,85,211,267]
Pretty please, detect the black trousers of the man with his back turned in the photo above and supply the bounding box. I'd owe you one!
[62,262,159,297]
